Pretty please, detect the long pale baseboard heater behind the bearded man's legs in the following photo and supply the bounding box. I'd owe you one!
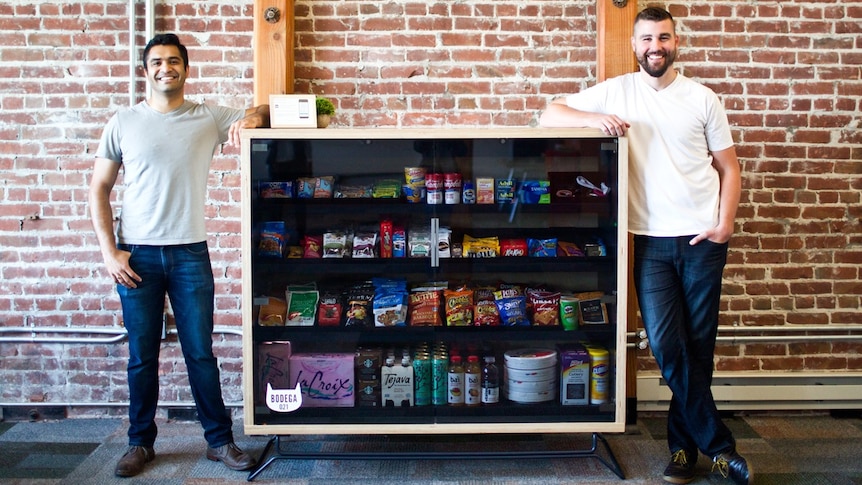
[637,372,862,411]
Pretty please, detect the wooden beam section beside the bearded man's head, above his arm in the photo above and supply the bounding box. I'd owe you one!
[596,0,638,82]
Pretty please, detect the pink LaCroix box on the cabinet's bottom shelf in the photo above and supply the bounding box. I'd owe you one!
[290,353,356,408]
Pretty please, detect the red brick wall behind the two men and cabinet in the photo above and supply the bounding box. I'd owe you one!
[0,0,862,412]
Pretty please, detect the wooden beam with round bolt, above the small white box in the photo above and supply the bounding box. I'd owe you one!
[254,0,293,106]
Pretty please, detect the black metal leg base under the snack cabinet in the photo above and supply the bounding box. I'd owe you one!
[247,433,626,482]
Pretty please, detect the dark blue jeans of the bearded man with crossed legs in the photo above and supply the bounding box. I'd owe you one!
[634,235,735,457]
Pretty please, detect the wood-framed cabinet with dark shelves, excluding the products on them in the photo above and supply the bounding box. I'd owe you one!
[241,128,628,435]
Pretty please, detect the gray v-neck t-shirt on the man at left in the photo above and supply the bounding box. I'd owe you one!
[96,101,245,246]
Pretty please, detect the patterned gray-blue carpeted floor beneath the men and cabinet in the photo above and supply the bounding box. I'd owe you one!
[0,413,862,485]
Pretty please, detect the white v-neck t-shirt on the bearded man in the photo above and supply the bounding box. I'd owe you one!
[566,73,733,237]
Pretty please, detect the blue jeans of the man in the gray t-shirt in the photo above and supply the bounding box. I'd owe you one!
[117,241,233,447]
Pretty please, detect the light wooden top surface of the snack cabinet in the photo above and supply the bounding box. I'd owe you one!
[242,127,617,140]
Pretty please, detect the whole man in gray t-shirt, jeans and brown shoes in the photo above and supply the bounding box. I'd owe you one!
[89,34,269,477]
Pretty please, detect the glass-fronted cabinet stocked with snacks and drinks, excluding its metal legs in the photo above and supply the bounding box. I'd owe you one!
[243,130,626,429]
